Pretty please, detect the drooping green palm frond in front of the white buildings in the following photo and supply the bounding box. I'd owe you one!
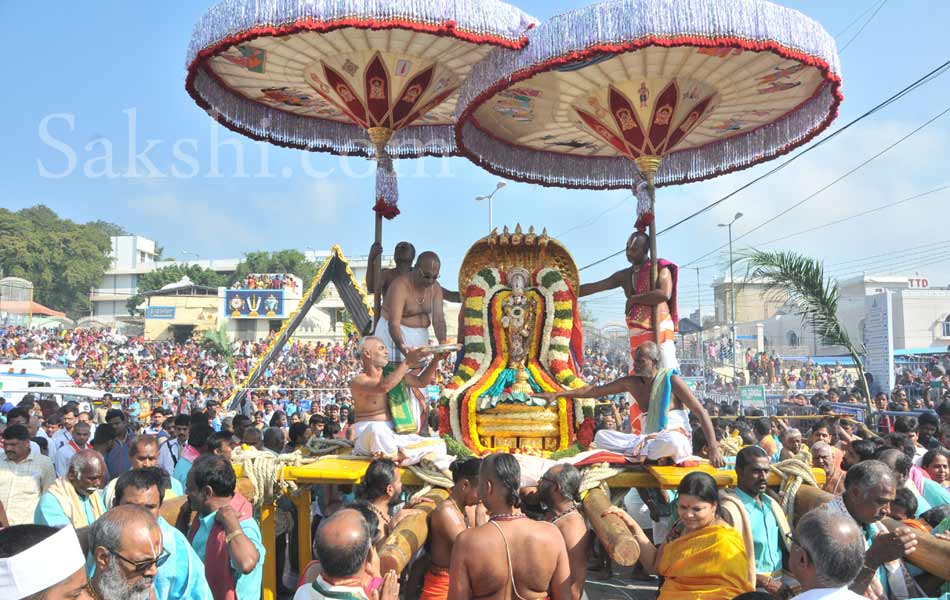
[737,250,873,419]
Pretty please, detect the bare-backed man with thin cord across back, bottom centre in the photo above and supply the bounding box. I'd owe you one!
[449,454,576,600]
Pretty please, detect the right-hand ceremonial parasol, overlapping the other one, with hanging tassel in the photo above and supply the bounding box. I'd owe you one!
[456,0,842,324]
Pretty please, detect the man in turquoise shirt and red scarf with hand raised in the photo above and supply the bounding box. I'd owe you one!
[185,454,264,600]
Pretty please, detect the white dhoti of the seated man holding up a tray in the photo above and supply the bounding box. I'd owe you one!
[353,421,453,471]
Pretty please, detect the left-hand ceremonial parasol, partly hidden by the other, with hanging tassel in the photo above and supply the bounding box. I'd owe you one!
[185,0,535,322]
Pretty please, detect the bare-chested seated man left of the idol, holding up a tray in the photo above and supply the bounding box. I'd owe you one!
[350,336,452,471]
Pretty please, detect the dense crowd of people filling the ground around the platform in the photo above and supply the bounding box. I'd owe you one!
[9,328,950,600]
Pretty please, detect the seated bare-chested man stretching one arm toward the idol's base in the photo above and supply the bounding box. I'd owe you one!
[536,342,725,467]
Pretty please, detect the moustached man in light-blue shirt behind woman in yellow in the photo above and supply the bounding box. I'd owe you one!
[735,446,789,597]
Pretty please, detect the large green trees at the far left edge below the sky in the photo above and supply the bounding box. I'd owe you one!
[0,205,112,319]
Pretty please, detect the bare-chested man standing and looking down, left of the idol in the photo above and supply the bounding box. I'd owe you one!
[374,252,446,362]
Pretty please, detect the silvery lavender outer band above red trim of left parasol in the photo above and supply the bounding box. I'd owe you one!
[186,0,538,66]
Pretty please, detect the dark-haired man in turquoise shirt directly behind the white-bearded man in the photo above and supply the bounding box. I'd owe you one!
[115,467,212,600]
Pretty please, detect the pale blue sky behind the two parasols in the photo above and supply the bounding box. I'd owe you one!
[0,0,950,324]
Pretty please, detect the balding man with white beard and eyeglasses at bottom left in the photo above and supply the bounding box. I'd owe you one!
[89,505,168,600]
